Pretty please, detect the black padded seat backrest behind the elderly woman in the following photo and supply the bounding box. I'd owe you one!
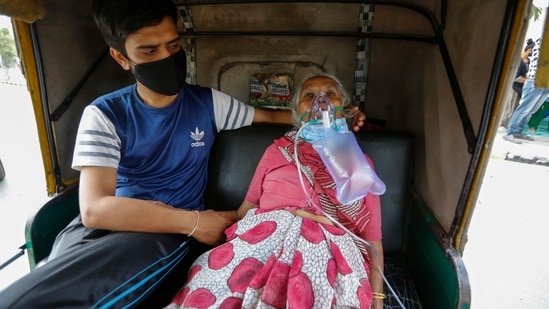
[204,124,412,253]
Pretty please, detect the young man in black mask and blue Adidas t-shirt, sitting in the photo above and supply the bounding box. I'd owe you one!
[0,0,363,308]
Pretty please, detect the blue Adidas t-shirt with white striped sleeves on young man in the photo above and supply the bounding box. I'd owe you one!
[72,84,254,209]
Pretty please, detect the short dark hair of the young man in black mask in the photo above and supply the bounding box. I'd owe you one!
[93,0,179,57]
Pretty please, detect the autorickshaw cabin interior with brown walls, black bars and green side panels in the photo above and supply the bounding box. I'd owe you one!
[2,0,544,308]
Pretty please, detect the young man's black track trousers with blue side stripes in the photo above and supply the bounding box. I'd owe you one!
[0,217,205,309]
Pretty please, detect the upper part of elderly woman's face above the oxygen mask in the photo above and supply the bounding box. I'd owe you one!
[298,76,342,115]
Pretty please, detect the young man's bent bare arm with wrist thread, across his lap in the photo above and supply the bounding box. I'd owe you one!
[79,166,231,244]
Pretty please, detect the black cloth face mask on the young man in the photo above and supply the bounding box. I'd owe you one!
[132,49,187,95]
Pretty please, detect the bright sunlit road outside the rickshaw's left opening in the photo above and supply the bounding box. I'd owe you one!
[0,82,47,289]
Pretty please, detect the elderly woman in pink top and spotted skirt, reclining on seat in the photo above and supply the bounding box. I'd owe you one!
[169,74,385,308]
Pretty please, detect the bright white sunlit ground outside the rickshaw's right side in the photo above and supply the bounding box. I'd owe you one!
[463,133,549,309]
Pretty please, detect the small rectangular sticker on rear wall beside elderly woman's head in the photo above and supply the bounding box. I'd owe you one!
[250,73,293,109]
